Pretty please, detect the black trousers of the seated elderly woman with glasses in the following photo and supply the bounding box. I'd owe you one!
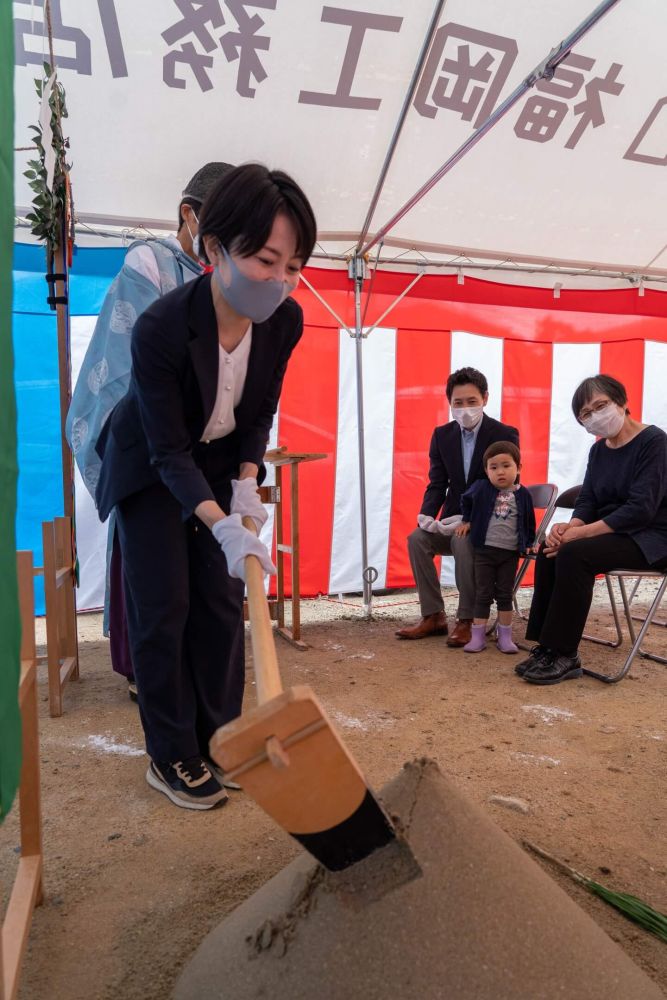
[526,534,658,656]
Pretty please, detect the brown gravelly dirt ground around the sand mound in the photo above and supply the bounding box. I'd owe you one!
[0,583,667,1000]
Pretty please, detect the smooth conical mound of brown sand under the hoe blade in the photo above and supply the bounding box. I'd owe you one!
[174,761,662,1000]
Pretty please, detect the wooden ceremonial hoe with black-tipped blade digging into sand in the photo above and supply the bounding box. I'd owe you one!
[210,518,396,871]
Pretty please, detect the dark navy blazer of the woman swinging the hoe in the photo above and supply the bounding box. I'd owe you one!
[96,274,303,521]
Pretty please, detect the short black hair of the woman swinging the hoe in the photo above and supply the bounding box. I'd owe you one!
[199,163,317,264]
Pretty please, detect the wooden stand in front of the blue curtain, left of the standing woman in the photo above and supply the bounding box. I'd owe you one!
[35,517,79,718]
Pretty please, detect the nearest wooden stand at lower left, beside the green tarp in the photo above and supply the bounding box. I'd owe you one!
[0,552,43,1000]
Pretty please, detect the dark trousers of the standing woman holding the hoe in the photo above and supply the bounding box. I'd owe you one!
[116,483,245,763]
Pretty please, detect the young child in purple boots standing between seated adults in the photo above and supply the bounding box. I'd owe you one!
[456,441,535,653]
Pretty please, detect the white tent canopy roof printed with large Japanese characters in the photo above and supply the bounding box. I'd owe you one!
[14,0,667,279]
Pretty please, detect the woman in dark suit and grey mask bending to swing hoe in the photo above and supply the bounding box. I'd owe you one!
[96,165,316,809]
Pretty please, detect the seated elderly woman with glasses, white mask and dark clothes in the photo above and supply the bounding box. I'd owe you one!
[515,375,667,684]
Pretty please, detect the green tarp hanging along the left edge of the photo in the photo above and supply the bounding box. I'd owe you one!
[0,0,21,821]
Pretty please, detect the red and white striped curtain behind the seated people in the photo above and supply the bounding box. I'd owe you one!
[74,269,667,606]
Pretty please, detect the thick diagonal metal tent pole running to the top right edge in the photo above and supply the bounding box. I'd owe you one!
[357,0,619,255]
